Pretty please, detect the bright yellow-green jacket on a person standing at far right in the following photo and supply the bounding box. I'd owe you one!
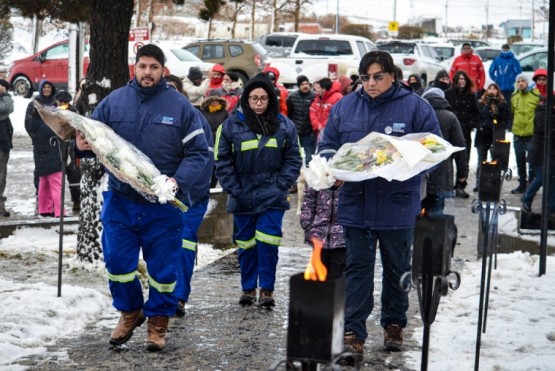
[511,89,540,137]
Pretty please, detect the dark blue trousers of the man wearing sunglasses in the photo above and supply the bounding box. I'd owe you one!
[345,227,414,341]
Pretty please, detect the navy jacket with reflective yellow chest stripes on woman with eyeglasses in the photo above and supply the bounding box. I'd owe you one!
[215,108,301,214]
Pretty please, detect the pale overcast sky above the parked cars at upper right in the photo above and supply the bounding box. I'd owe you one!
[313,0,549,28]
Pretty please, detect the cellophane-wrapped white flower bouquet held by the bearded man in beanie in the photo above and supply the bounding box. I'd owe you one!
[33,100,187,212]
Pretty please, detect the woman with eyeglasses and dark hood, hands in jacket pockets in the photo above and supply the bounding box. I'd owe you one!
[214,73,301,308]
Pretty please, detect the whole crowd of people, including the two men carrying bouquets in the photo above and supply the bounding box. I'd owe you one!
[0,43,555,364]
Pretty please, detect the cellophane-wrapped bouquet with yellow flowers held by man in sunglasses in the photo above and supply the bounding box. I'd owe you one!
[305,132,464,189]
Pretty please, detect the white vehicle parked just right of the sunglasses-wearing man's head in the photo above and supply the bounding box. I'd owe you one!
[378,41,447,84]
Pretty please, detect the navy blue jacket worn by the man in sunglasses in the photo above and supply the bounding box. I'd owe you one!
[318,83,441,230]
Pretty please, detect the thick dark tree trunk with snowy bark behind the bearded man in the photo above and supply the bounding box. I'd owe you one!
[77,0,133,263]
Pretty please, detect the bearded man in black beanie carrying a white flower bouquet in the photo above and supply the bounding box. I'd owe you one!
[76,44,210,351]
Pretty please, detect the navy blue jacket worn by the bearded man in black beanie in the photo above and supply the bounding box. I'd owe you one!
[91,79,210,205]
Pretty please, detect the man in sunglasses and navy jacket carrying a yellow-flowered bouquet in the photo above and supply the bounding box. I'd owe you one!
[318,51,441,360]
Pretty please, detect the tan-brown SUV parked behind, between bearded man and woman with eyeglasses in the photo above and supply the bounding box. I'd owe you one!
[183,39,268,84]
